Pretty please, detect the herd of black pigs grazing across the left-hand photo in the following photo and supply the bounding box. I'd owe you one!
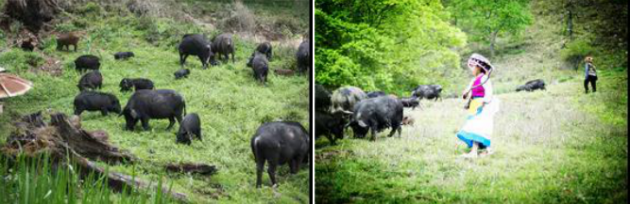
[51,30,312,187]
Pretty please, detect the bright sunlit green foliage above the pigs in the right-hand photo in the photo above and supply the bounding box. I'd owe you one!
[315,0,465,95]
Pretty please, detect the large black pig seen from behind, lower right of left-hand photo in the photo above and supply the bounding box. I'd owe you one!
[250,122,311,188]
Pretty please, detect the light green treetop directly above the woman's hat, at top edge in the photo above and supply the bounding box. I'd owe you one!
[448,0,533,56]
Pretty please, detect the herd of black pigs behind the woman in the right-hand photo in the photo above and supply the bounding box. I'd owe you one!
[315,79,545,145]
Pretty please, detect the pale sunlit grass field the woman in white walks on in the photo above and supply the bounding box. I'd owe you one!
[315,69,628,203]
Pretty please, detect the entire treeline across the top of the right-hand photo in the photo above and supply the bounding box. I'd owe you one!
[315,0,628,95]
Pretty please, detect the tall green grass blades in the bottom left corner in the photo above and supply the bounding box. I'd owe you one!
[0,155,173,204]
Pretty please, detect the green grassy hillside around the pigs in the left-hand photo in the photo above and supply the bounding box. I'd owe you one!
[0,0,310,203]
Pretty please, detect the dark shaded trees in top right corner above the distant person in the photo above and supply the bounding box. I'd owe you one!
[533,0,628,70]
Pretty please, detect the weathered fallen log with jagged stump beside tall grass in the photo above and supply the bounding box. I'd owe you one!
[0,112,187,202]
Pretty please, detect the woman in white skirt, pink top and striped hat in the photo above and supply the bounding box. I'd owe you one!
[457,54,499,158]
